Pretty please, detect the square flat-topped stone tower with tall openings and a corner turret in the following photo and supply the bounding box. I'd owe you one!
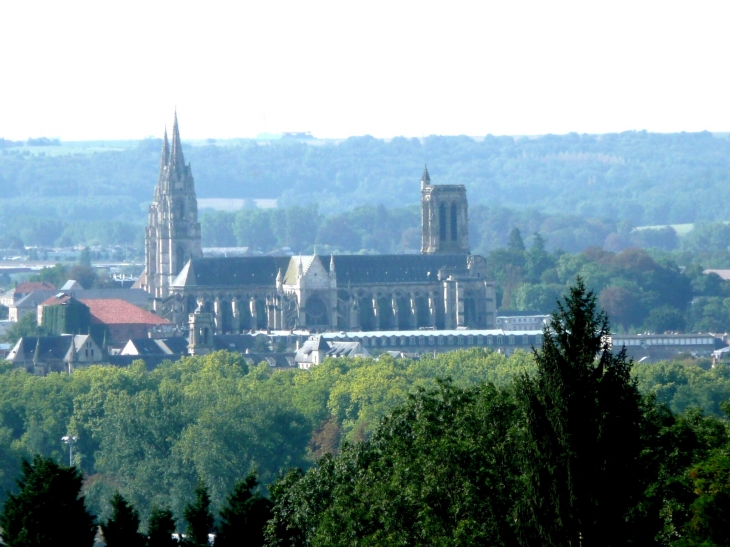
[421,168,469,254]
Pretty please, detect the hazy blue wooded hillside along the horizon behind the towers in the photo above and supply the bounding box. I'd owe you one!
[0,132,730,246]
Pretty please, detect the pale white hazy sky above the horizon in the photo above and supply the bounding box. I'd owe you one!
[0,0,730,140]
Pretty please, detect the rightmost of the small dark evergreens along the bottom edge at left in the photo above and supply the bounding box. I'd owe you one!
[215,473,271,547]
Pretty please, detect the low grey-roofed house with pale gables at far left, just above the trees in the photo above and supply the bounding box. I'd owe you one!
[5,334,104,376]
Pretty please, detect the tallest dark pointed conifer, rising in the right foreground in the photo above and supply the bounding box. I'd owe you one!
[517,278,644,547]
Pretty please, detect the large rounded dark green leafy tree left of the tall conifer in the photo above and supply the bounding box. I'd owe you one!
[267,383,519,546]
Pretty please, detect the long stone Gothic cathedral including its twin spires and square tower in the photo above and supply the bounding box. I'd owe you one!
[138,114,495,336]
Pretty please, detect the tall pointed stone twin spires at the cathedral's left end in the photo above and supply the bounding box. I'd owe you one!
[141,112,203,298]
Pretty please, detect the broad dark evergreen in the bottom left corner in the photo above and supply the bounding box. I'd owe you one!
[0,456,96,547]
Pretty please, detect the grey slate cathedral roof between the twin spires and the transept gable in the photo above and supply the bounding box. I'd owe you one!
[172,256,290,287]
